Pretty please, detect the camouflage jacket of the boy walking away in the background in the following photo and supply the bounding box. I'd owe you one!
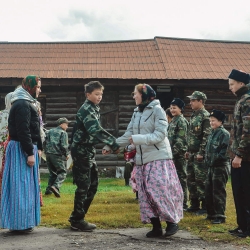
[44,126,69,157]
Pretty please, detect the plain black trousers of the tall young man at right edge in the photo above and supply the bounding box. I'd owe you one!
[231,161,250,232]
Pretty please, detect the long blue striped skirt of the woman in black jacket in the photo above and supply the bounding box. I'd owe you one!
[0,141,40,230]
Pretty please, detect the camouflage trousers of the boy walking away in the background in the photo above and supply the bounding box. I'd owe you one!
[46,154,67,191]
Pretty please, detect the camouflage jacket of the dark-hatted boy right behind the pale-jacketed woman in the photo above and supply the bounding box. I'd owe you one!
[168,114,189,157]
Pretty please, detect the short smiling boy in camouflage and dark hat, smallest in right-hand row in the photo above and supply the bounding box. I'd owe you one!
[205,109,230,224]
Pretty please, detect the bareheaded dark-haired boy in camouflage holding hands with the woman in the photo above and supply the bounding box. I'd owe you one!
[69,81,120,231]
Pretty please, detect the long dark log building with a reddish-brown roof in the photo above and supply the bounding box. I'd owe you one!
[0,37,250,168]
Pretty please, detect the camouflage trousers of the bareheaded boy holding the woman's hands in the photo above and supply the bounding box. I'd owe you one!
[69,143,98,223]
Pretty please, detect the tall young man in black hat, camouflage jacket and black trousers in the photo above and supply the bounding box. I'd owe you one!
[228,69,250,238]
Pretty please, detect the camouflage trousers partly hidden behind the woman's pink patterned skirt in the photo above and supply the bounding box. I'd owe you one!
[174,155,188,207]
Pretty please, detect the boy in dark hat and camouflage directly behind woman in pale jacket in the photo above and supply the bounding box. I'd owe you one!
[168,98,189,210]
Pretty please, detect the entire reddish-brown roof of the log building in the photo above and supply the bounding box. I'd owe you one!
[0,37,250,79]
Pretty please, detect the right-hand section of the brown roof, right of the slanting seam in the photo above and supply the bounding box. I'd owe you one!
[155,37,250,79]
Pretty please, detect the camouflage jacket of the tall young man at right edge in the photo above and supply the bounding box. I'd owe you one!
[229,86,250,161]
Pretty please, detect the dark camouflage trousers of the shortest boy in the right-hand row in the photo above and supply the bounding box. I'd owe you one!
[205,162,229,218]
